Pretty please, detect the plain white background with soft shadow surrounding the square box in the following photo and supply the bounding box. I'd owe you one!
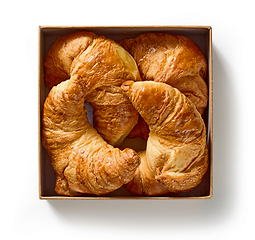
[0,0,255,239]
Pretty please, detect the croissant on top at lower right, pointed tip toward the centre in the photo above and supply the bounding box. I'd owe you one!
[122,81,208,195]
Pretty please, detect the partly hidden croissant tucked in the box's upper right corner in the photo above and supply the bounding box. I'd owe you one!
[120,33,208,115]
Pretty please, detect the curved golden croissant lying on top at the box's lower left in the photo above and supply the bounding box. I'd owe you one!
[42,79,140,196]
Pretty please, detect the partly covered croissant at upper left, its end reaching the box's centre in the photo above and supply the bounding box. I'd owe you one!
[44,32,141,145]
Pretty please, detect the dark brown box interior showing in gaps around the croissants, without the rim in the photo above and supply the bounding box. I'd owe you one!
[39,27,211,198]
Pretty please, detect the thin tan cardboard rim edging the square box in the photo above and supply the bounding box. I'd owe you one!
[38,25,213,200]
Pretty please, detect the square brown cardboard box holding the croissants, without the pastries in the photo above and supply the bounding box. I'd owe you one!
[38,26,213,200]
